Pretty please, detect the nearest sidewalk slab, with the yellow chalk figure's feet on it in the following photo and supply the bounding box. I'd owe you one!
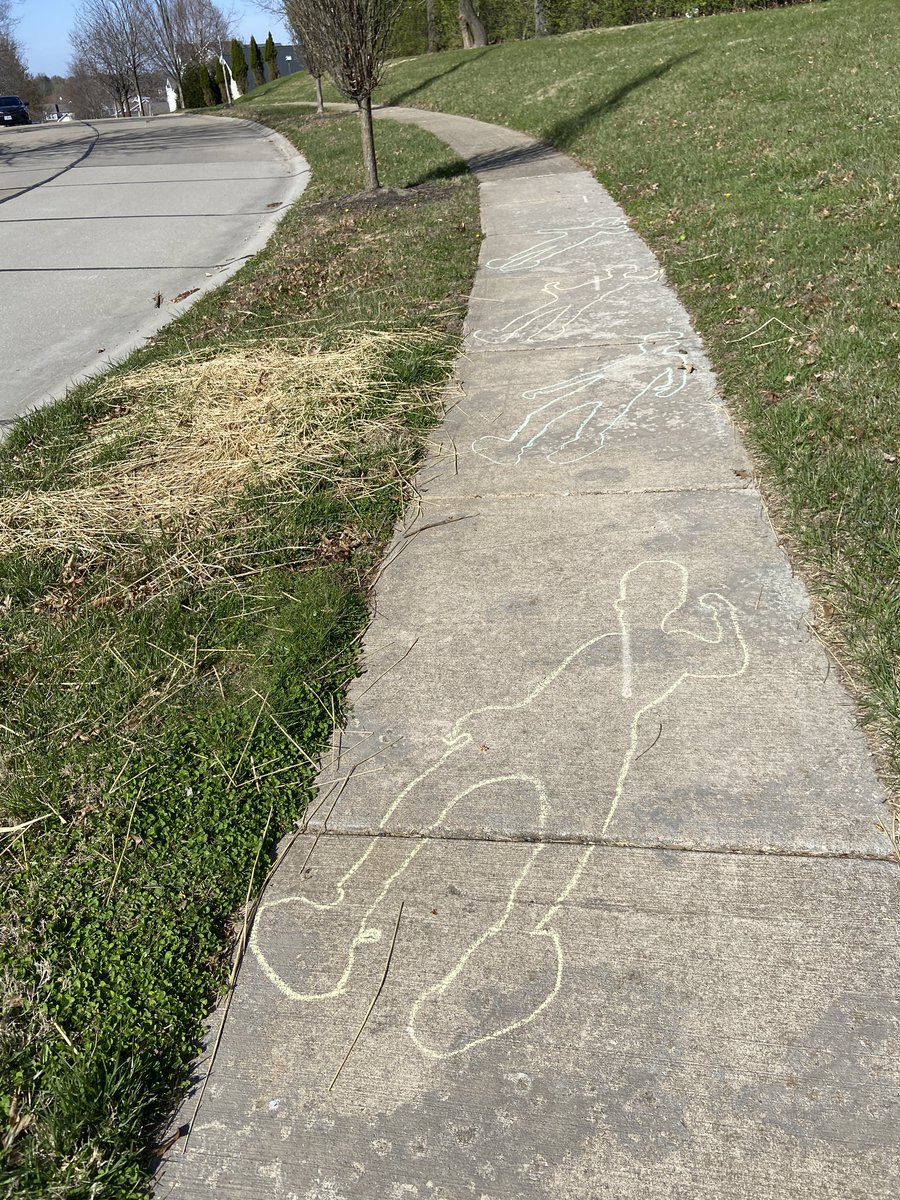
[160,836,900,1200]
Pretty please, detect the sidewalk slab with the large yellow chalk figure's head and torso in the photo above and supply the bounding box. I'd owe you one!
[312,491,889,857]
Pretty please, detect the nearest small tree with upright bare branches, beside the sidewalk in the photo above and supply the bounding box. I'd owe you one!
[294,0,397,192]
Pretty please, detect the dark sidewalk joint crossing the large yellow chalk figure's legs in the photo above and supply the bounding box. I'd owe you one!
[306,827,900,865]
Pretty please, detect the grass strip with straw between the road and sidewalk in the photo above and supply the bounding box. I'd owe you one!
[0,110,479,1200]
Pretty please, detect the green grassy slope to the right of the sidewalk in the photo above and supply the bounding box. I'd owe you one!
[268,0,900,778]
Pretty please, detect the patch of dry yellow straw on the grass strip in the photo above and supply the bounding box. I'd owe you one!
[0,334,434,554]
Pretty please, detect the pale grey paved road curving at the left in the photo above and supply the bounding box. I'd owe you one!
[0,115,308,421]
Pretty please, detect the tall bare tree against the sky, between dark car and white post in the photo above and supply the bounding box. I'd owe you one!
[71,0,152,116]
